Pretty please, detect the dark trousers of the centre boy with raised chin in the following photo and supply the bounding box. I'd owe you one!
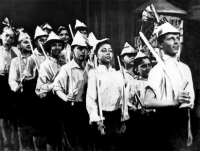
[92,109,125,151]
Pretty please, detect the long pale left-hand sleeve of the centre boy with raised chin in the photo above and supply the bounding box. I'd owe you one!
[86,69,100,123]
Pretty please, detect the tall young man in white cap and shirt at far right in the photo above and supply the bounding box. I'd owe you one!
[144,22,194,150]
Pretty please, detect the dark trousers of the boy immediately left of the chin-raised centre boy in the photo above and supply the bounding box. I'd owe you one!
[62,102,90,151]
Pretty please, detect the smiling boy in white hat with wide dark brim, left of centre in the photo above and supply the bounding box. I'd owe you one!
[36,32,64,151]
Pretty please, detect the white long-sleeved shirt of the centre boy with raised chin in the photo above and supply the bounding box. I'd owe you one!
[86,65,128,123]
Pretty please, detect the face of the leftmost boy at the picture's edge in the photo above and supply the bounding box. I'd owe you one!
[1,31,14,46]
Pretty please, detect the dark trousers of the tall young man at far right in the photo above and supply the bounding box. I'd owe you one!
[151,107,188,151]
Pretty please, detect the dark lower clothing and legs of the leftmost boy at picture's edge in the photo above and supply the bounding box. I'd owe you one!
[0,74,17,147]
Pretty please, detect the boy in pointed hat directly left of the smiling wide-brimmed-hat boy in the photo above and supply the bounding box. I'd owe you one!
[22,26,48,149]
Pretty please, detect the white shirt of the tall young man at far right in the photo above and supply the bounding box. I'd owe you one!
[147,54,194,104]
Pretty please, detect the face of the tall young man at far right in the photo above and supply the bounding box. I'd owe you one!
[161,34,180,56]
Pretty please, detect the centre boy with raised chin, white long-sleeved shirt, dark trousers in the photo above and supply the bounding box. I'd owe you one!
[86,38,129,150]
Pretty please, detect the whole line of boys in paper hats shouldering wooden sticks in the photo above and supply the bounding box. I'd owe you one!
[0,16,194,151]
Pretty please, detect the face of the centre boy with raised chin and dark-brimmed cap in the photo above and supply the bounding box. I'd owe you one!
[97,44,113,64]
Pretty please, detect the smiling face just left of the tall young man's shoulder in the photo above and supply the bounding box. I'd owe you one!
[137,58,152,79]
